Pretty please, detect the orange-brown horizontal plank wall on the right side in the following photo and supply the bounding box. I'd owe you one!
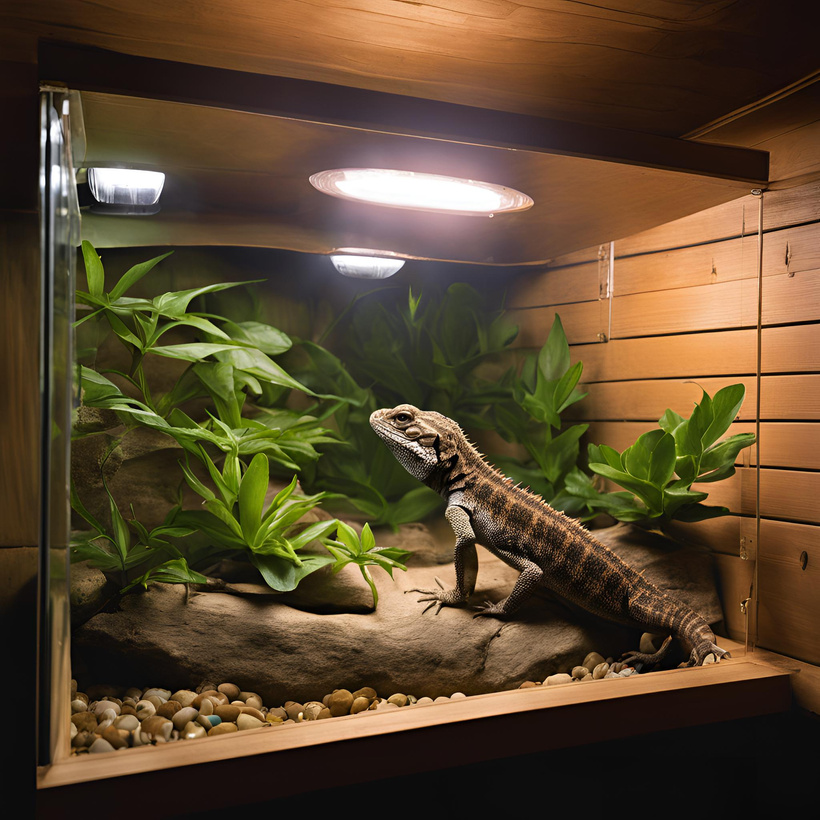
[512,183,820,664]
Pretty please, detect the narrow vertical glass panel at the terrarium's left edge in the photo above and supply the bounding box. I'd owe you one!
[37,92,79,765]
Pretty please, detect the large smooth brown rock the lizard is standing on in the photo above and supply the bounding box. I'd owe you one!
[73,525,721,705]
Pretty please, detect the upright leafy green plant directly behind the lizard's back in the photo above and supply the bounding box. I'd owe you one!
[493,314,588,514]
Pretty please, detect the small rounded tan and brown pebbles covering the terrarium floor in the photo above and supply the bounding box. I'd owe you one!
[71,652,672,754]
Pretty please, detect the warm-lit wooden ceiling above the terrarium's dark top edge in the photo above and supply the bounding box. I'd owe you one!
[0,0,815,136]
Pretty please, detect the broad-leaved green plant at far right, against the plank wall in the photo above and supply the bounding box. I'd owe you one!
[573,384,755,526]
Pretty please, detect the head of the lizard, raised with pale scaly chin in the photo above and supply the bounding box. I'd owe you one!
[370,404,462,481]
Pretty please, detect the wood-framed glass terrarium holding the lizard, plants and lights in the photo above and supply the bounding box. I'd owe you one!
[32,65,787,808]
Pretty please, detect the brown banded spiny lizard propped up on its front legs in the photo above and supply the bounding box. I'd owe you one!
[370,404,729,668]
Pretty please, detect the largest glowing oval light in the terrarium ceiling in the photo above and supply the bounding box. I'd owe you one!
[310,168,533,216]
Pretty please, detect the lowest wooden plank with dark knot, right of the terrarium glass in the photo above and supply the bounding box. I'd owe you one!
[758,521,820,663]
